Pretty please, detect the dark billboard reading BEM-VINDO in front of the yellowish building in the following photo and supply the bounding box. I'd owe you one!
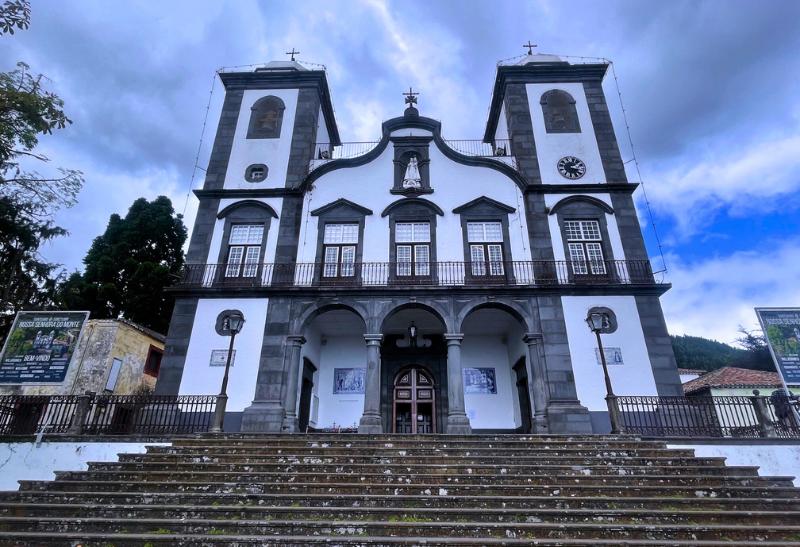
[0,311,89,384]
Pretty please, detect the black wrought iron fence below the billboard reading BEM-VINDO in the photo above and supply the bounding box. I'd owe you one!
[0,394,216,435]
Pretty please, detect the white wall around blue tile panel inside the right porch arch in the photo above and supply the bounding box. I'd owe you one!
[461,335,521,429]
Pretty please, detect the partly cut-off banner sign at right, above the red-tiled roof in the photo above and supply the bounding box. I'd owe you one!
[756,308,800,385]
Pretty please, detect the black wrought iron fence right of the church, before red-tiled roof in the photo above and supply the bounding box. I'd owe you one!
[616,392,800,438]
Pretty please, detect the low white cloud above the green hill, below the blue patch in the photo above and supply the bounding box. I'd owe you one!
[662,238,800,342]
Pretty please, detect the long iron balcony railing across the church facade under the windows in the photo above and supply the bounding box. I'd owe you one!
[178,260,655,288]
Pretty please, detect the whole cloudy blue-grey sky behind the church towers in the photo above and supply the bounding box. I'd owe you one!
[0,0,800,341]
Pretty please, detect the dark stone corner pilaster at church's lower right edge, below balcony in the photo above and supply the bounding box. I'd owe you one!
[635,295,683,396]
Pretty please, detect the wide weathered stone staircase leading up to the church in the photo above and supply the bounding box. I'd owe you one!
[0,434,800,547]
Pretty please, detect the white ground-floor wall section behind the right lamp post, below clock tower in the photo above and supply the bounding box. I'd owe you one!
[564,295,658,411]
